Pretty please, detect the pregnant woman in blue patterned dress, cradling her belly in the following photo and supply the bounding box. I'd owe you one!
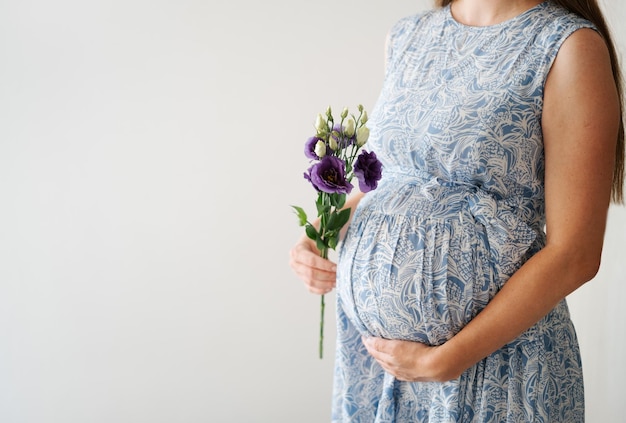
[291,0,624,423]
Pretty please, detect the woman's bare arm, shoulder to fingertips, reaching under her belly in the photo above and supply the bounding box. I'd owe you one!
[365,29,620,380]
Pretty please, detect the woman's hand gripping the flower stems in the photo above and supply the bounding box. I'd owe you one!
[289,236,337,295]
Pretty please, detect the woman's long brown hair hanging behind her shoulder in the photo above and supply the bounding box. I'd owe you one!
[435,0,624,203]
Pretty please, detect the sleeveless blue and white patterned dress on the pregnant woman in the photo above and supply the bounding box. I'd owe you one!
[332,1,593,423]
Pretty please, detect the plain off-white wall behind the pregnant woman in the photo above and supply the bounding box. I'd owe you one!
[0,0,626,423]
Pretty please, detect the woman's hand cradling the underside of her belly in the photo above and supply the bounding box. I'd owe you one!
[362,337,458,382]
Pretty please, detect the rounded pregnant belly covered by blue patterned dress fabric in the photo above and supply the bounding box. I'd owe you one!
[337,206,498,345]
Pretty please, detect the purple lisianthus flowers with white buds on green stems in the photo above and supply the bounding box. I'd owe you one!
[292,105,382,358]
